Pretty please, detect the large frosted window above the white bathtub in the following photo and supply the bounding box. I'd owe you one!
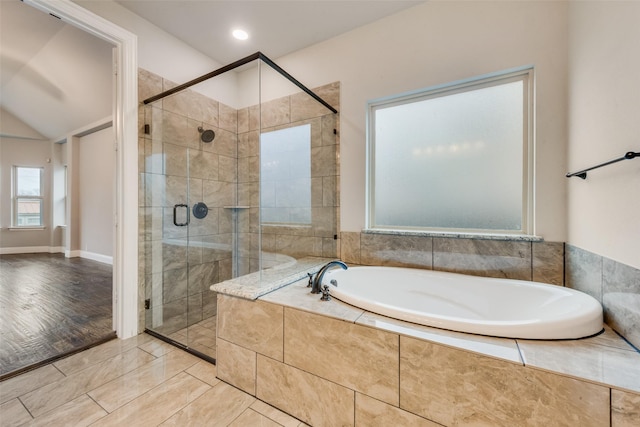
[368,70,531,233]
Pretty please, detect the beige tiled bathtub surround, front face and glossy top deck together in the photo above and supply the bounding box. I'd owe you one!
[217,280,640,427]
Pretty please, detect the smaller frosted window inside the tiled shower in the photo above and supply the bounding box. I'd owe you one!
[260,125,311,225]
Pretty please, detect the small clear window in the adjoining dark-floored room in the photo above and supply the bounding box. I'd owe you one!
[13,166,44,228]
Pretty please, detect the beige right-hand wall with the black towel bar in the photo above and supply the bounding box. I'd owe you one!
[567,2,640,268]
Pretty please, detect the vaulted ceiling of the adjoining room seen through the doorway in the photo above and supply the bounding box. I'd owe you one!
[0,0,113,139]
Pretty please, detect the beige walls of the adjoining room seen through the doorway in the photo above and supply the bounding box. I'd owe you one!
[0,124,115,262]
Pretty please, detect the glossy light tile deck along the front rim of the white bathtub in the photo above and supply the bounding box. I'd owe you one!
[259,279,640,394]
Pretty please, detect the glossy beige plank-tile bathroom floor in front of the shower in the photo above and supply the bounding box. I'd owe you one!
[0,334,305,427]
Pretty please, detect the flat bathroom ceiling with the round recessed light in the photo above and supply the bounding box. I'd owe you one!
[117,0,425,65]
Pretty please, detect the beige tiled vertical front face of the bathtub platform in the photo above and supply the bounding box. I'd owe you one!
[217,296,640,426]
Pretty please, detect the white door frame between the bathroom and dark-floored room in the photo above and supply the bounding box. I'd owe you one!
[23,0,141,339]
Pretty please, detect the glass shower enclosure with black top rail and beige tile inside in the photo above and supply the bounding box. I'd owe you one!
[140,52,339,361]
